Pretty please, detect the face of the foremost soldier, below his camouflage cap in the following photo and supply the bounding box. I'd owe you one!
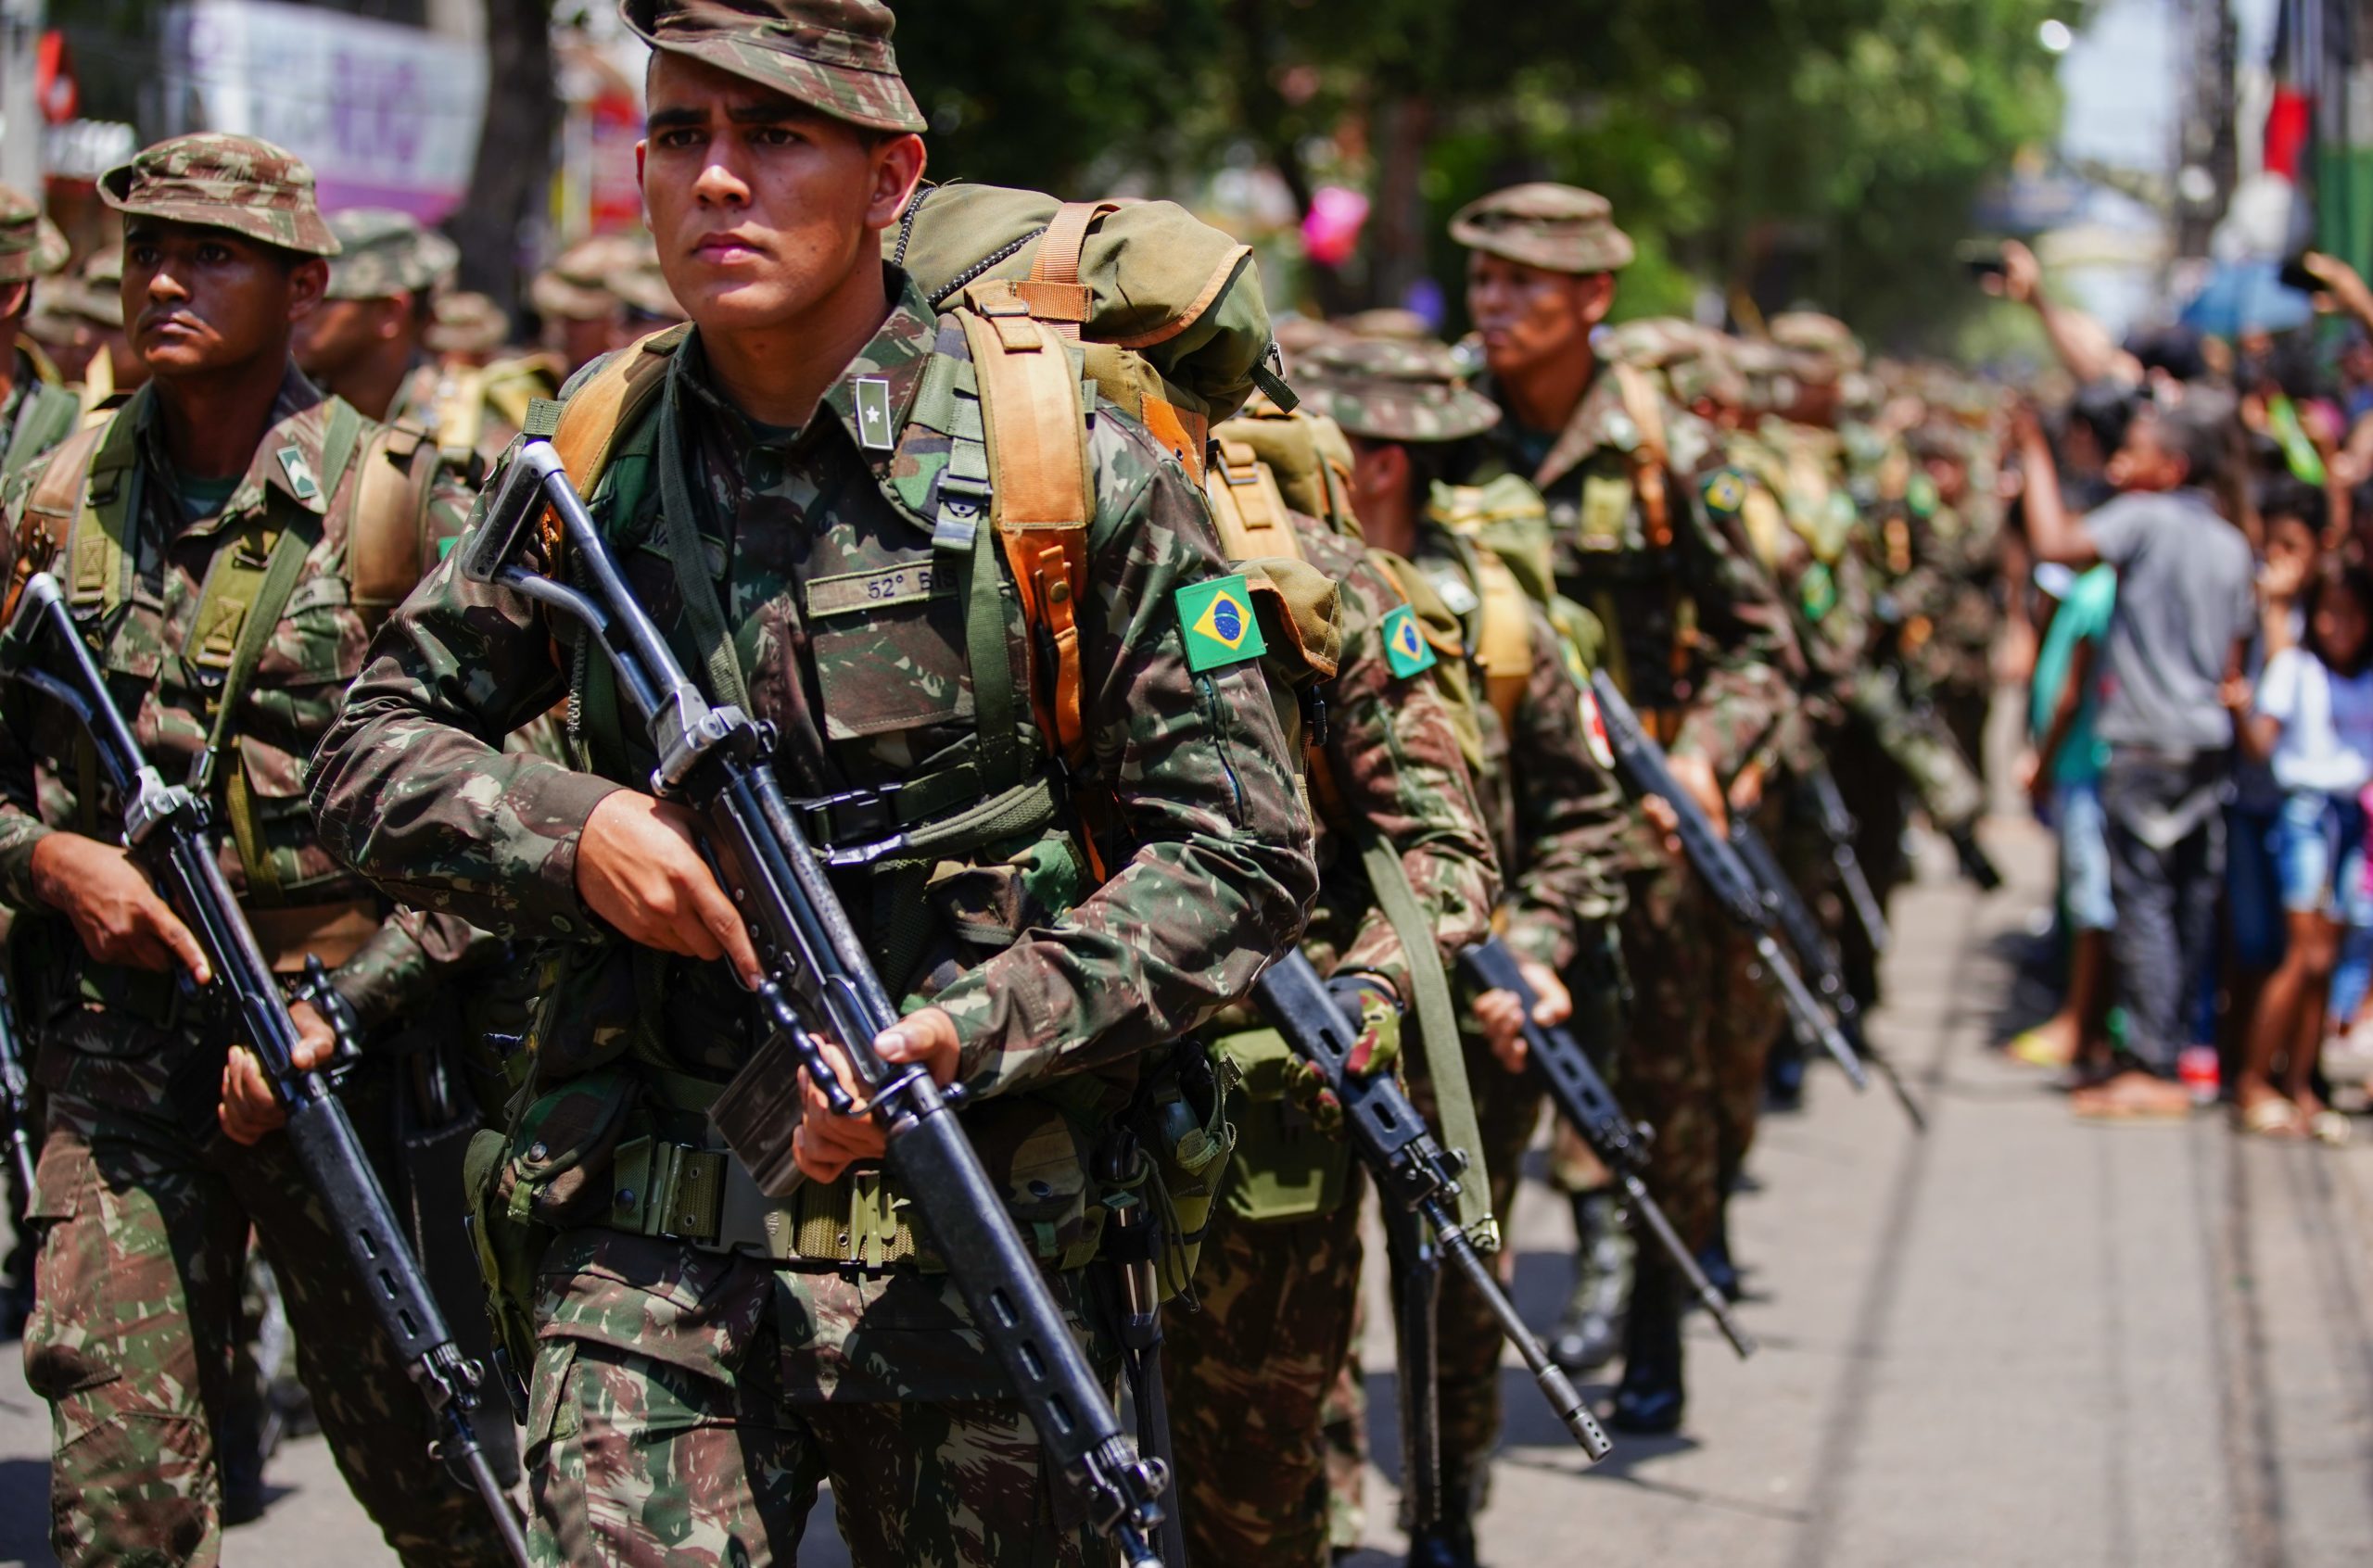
[636,55,923,332]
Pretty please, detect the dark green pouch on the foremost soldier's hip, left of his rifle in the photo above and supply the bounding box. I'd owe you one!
[463,1068,641,1387]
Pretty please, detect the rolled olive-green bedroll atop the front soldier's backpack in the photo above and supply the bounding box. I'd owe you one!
[882,185,1293,479]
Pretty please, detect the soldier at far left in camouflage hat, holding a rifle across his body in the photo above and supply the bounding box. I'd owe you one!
[0,135,503,1563]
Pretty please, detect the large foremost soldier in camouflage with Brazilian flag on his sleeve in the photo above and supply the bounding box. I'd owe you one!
[313,0,1317,1565]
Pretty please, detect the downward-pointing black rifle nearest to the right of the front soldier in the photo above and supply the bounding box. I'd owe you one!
[1253,951,1611,1463]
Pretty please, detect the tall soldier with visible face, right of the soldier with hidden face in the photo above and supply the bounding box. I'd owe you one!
[1450,185,1798,1433]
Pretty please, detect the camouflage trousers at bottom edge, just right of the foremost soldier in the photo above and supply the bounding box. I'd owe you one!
[1162,1167,1367,1568]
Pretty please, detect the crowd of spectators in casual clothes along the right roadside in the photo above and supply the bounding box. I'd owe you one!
[1999,245,2373,1144]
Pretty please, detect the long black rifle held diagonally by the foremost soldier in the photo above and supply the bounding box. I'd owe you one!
[461,441,1170,1568]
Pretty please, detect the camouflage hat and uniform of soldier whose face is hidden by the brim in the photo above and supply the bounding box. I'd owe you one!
[1298,339,1626,1527]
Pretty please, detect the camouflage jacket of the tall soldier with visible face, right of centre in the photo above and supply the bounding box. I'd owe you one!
[1462,363,1801,780]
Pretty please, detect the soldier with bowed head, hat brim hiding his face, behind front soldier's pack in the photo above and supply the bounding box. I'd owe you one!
[1296,339,1626,1568]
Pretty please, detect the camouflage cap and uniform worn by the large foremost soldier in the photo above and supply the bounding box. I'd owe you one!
[313,0,1317,1565]
